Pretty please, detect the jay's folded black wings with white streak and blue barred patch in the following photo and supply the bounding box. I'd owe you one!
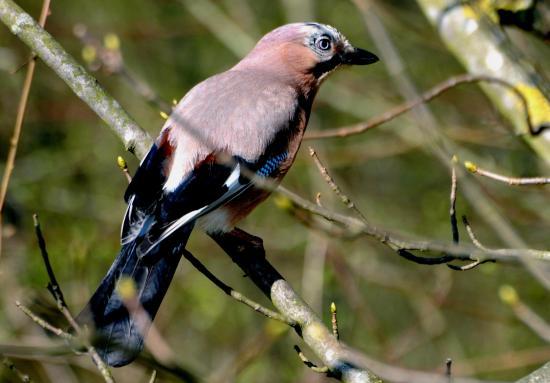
[121,132,288,257]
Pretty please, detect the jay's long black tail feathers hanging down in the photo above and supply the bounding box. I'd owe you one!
[77,230,190,367]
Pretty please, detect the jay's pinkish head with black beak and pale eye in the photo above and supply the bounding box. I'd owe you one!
[239,22,378,82]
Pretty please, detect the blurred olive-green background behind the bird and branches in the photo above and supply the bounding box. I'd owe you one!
[0,0,550,382]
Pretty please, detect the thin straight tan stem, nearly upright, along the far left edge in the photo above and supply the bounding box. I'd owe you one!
[0,0,50,256]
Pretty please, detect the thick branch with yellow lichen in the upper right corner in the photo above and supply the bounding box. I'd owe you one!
[417,0,550,163]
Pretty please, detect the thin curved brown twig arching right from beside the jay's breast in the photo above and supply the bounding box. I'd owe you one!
[304,74,539,140]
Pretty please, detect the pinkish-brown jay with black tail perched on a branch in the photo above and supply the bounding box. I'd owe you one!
[77,22,378,367]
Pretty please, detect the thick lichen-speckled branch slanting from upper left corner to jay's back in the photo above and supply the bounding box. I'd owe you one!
[0,0,151,158]
